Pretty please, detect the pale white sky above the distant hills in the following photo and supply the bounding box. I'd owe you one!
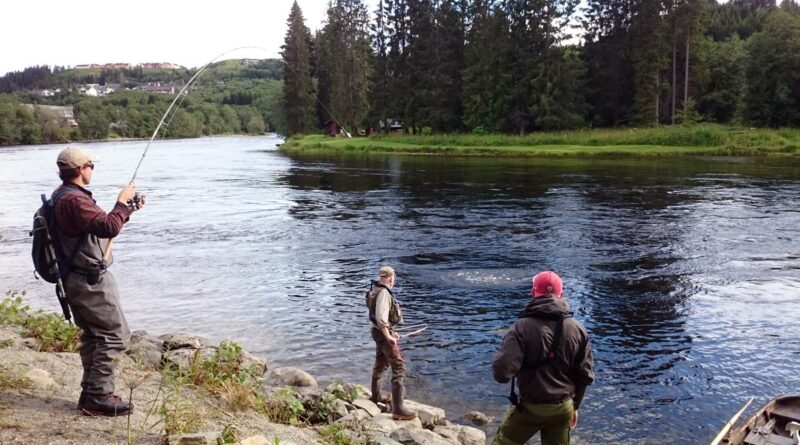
[0,0,376,76]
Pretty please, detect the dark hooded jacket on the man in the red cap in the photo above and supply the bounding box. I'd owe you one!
[492,297,594,409]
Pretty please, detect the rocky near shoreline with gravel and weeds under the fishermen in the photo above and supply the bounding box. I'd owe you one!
[0,325,490,445]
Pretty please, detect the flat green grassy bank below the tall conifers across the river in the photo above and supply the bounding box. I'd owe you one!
[283,124,800,157]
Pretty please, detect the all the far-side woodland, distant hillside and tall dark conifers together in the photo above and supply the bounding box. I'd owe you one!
[0,0,800,145]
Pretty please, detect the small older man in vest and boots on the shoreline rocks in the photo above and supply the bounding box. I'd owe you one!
[367,266,417,420]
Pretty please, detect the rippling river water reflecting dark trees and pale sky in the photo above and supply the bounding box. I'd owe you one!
[0,137,800,444]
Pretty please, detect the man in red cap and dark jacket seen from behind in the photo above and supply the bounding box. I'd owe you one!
[492,271,594,445]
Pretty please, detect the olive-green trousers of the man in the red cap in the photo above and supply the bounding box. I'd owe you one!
[492,399,575,445]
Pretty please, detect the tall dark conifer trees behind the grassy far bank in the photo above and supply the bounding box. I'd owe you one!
[282,0,800,134]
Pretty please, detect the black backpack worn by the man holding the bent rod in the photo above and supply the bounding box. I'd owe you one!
[30,188,86,321]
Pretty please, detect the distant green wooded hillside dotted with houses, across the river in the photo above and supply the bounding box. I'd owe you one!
[0,60,282,145]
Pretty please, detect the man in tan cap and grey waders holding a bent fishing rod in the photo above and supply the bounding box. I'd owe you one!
[52,147,144,416]
